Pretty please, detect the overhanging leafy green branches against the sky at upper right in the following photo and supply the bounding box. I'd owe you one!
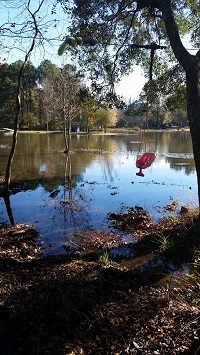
[59,0,200,103]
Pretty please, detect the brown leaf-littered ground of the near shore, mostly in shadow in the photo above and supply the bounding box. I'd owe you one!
[0,211,200,355]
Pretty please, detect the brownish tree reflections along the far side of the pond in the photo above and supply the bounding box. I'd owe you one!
[1,131,193,190]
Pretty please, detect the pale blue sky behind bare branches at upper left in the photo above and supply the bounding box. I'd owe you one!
[0,0,69,66]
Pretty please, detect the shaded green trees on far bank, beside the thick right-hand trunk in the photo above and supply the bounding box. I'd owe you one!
[133,61,187,126]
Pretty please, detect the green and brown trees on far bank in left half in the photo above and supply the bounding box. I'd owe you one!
[0,60,105,130]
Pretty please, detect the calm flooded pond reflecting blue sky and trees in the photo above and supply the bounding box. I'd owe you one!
[0,131,198,254]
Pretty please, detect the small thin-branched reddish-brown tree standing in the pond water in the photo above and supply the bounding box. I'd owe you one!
[40,64,80,153]
